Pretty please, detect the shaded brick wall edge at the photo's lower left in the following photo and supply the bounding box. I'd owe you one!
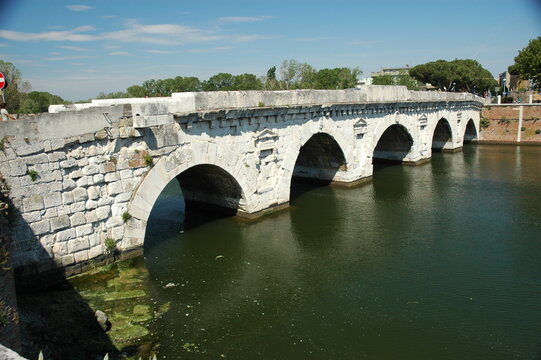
[0,175,21,351]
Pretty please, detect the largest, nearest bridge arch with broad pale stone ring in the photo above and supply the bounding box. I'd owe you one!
[125,142,256,250]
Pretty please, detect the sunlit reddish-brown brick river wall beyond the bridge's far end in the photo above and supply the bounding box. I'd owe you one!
[480,104,541,144]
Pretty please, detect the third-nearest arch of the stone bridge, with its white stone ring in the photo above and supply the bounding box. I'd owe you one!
[370,115,421,163]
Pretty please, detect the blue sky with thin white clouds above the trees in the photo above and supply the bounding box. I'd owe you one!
[0,0,541,100]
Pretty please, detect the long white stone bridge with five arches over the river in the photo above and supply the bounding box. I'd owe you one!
[0,86,483,284]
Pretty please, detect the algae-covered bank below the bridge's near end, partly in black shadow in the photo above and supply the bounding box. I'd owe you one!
[19,257,169,359]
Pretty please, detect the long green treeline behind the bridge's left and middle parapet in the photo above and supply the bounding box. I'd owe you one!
[98,59,362,99]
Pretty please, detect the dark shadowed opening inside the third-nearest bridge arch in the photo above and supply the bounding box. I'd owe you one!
[372,124,413,164]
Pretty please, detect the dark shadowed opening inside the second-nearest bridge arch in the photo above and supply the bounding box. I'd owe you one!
[290,132,347,200]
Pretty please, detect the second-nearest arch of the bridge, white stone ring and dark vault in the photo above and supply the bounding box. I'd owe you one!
[277,119,354,203]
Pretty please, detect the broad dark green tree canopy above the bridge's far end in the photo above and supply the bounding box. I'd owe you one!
[409,59,498,93]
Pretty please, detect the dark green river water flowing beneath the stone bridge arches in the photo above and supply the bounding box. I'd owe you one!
[98,145,541,360]
